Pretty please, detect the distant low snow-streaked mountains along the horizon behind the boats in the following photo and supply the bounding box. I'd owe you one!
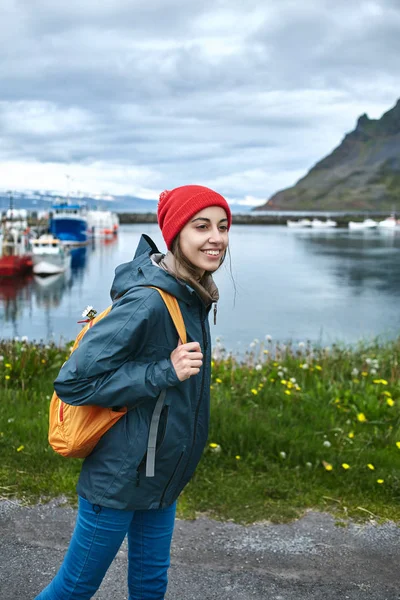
[0,191,251,214]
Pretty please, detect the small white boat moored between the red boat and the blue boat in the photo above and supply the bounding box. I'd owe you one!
[31,235,71,277]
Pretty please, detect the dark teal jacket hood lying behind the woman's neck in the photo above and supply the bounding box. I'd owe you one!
[110,234,195,304]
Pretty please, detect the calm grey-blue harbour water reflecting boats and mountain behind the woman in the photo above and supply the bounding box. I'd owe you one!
[0,225,400,351]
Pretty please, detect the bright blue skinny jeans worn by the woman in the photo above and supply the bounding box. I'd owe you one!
[35,497,176,600]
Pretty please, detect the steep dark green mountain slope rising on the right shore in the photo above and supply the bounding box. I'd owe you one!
[254,100,400,212]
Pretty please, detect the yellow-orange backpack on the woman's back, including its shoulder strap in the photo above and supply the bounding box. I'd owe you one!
[49,286,186,458]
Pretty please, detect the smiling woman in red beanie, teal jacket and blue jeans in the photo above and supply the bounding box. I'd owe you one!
[36,185,232,600]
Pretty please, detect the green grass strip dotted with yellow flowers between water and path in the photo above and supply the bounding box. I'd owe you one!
[0,339,400,522]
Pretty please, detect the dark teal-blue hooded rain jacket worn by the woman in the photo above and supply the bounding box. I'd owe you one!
[54,235,216,510]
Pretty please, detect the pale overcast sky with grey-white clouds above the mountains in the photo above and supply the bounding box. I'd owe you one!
[0,0,400,205]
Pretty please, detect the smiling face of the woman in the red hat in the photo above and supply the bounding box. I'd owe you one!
[179,206,229,277]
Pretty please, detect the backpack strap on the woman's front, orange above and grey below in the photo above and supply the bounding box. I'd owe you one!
[146,285,187,477]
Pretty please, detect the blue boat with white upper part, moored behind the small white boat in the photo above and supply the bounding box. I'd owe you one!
[50,200,88,245]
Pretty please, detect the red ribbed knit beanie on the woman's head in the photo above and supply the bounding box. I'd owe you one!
[157,185,232,250]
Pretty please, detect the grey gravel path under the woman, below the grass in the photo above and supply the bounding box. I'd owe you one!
[0,500,400,600]
